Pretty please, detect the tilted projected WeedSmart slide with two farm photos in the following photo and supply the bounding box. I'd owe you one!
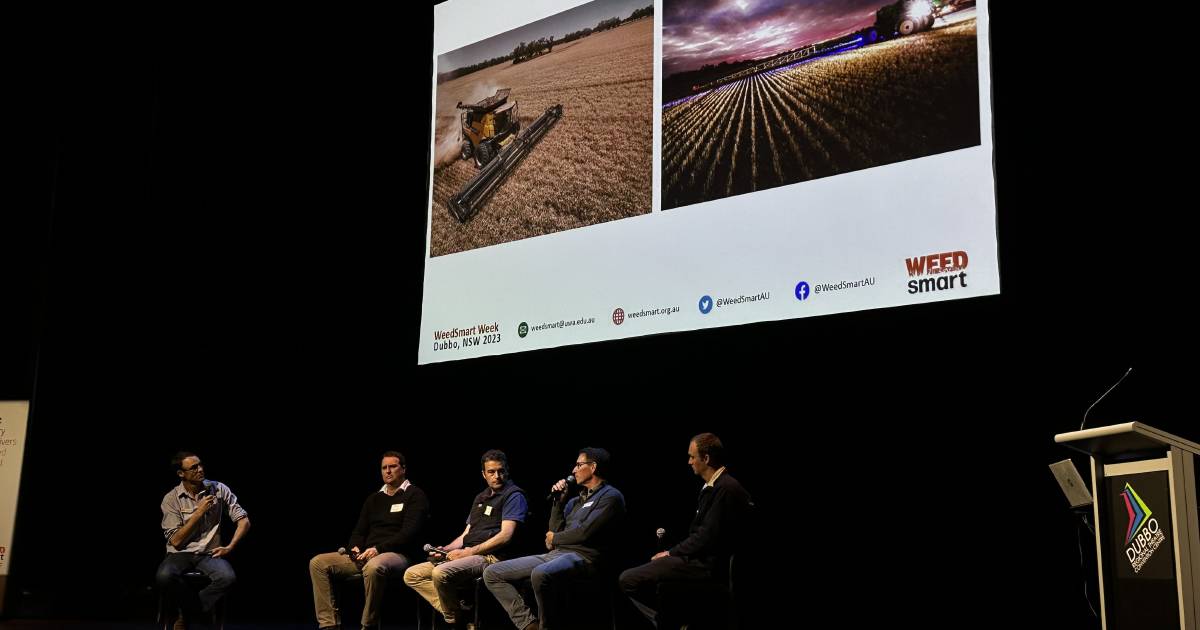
[418,0,1000,364]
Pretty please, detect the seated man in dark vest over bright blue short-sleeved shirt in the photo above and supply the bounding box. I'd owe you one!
[404,449,529,628]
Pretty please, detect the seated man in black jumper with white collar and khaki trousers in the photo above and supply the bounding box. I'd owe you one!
[308,451,430,629]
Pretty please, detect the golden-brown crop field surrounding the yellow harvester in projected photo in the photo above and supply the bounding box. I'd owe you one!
[430,19,654,256]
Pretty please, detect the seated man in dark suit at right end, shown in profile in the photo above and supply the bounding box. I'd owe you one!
[620,433,752,628]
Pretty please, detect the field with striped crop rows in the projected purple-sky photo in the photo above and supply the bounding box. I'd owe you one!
[662,19,979,209]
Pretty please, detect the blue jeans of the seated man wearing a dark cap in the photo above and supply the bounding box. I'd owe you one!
[484,550,595,630]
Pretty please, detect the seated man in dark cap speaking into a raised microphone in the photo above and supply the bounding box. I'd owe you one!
[484,448,625,630]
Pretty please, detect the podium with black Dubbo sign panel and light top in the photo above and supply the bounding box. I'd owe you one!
[1054,422,1200,630]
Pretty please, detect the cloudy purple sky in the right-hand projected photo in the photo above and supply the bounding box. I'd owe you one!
[662,0,889,76]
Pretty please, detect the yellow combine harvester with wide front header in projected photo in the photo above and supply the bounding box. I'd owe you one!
[450,88,563,223]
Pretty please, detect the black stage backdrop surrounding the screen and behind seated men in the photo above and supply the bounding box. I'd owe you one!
[7,2,1200,628]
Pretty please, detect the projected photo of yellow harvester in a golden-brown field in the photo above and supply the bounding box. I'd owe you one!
[430,0,654,257]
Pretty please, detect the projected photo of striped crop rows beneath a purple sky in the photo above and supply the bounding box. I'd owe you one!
[662,0,980,209]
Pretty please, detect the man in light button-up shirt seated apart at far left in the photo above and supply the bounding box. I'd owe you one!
[156,451,250,623]
